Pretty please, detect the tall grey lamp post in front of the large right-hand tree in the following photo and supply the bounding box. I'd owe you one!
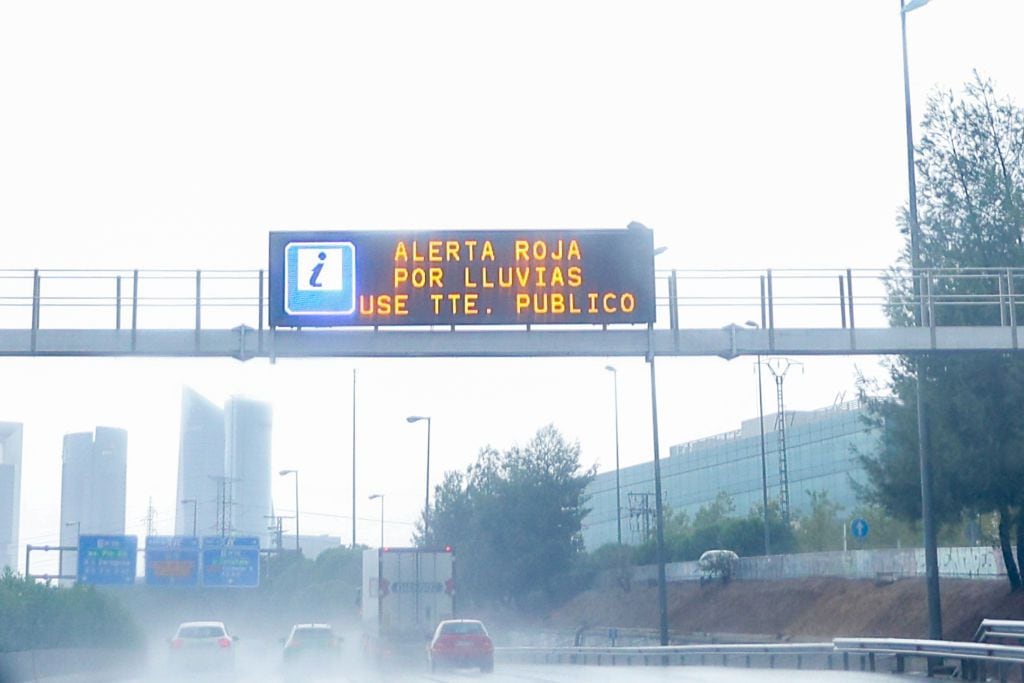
[899,0,942,640]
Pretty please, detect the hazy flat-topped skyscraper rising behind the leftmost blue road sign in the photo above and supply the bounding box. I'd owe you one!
[60,427,128,574]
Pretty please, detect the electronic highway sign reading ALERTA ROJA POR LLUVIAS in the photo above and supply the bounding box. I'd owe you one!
[269,227,654,328]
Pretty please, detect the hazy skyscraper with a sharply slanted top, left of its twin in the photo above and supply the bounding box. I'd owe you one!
[174,387,227,536]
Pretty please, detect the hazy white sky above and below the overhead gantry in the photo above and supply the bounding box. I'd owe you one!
[0,0,1024,573]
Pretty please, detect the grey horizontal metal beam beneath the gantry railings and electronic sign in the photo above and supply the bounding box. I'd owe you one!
[0,327,1019,360]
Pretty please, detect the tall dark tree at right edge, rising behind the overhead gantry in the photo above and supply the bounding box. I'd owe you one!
[861,74,1024,589]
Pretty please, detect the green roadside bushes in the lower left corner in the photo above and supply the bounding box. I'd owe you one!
[0,568,142,652]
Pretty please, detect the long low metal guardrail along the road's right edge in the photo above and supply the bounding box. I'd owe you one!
[497,638,1024,682]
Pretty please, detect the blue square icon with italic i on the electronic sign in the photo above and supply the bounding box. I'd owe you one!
[285,242,355,315]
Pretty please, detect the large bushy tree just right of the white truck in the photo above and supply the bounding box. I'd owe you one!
[417,425,594,607]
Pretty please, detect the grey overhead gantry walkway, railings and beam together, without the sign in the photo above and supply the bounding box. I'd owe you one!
[0,267,1024,357]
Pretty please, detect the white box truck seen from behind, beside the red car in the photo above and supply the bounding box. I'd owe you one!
[360,546,456,661]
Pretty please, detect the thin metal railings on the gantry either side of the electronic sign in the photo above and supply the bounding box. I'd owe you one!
[0,267,1024,330]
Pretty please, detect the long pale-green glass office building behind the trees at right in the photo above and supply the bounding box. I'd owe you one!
[583,401,878,550]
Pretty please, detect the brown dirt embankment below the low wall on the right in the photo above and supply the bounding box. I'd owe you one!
[550,579,1024,640]
